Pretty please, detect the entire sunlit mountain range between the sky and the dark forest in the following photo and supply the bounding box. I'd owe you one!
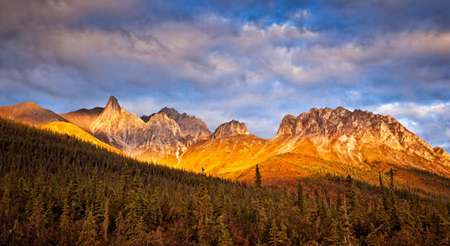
[0,97,450,194]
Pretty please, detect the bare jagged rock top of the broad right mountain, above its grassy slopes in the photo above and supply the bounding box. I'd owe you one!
[277,107,446,165]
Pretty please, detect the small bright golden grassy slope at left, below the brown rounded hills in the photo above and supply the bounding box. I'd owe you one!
[41,121,122,154]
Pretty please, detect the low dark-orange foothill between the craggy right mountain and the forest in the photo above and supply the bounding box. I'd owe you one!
[239,153,450,196]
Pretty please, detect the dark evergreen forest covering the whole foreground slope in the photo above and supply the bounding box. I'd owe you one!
[0,120,450,245]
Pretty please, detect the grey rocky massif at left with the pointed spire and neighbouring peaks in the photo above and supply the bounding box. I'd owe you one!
[90,97,214,164]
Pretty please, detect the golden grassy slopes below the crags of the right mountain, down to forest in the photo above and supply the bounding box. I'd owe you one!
[175,136,450,195]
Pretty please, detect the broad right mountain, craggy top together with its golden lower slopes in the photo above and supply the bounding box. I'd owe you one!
[178,108,450,194]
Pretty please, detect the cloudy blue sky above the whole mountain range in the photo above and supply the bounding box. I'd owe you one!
[0,0,450,150]
